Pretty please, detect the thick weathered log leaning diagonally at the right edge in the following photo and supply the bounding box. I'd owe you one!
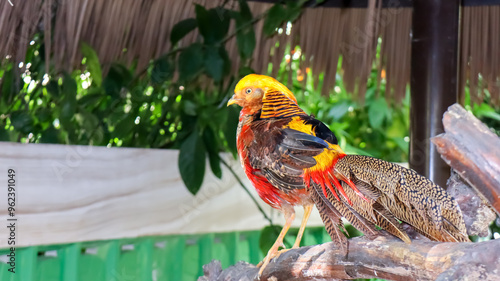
[432,104,500,215]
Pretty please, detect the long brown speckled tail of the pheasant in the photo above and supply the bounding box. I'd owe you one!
[311,155,470,243]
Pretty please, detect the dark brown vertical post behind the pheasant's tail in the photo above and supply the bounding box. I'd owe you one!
[409,0,459,186]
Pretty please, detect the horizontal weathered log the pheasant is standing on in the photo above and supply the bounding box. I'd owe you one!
[198,237,500,281]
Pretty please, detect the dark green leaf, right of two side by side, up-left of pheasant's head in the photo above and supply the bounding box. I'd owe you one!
[204,46,231,82]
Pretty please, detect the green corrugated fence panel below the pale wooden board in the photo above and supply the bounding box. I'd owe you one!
[0,227,336,281]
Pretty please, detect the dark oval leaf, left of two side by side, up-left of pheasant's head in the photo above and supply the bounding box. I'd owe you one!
[178,43,203,82]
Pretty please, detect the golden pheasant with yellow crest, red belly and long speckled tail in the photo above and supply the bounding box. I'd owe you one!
[227,74,469,274]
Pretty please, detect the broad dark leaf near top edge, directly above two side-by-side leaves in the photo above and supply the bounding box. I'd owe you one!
[195,4,230,45]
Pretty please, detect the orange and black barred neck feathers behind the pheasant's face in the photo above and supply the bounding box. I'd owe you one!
[260,90,307,119]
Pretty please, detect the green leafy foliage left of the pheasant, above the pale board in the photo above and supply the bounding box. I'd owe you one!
[0,0,286,191]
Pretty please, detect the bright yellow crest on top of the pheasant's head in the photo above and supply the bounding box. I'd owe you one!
[234,74,297,104]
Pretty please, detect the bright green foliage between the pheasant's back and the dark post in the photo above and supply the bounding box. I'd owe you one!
[278,47,409,162]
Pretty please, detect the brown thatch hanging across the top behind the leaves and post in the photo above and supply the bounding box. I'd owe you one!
[0,0,500,104]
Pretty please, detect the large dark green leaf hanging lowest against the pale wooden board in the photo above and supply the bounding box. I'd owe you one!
[178,130,206,195]
